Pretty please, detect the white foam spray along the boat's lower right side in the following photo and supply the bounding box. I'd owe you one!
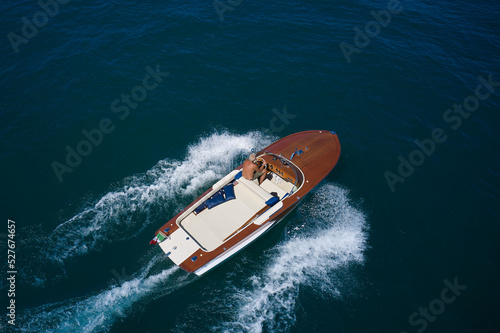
[217,184,367,332]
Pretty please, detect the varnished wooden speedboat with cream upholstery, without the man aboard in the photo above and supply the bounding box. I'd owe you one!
[150,131,340,275]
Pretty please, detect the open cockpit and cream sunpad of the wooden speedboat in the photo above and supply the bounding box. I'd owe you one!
[177,151,304,252]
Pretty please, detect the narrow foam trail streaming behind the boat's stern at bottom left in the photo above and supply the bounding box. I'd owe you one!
[18,256,188,333]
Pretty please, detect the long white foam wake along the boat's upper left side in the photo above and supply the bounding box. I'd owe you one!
[19,131,275,287]
